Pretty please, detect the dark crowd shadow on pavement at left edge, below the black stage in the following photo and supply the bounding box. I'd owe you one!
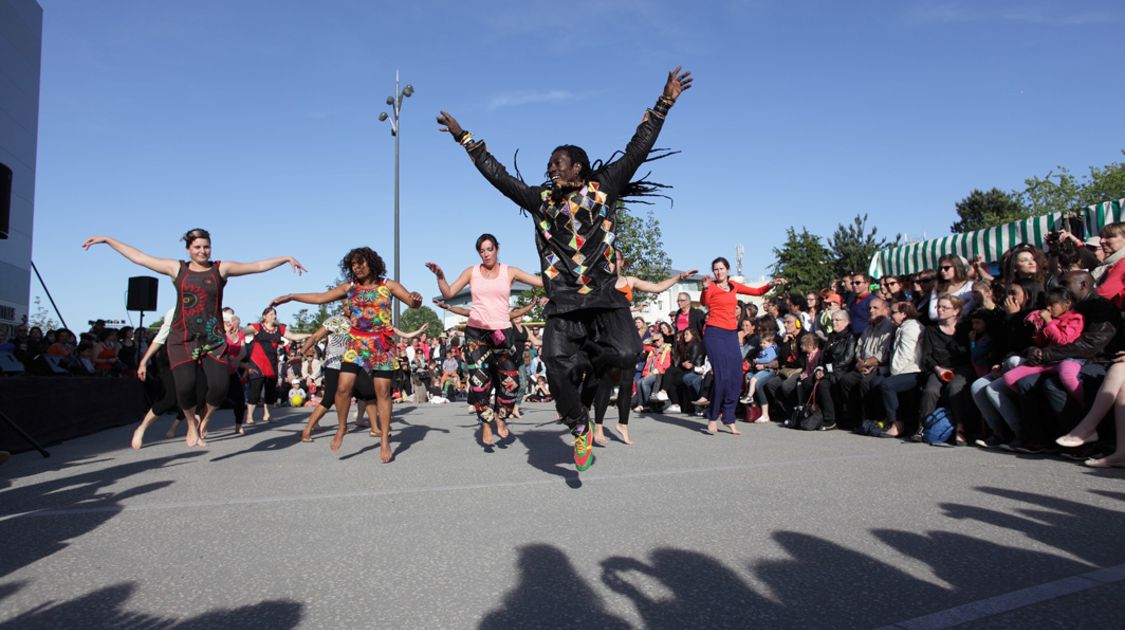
[0,451,203,576]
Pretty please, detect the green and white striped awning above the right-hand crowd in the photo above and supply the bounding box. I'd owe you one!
[867,199,1125,278]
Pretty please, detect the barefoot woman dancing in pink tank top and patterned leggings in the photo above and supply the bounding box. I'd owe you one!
[426,234,543,449]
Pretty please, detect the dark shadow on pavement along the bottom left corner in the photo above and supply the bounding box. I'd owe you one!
[0,582,303,630]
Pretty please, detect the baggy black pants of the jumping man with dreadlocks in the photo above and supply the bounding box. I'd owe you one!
[542,308,641,431]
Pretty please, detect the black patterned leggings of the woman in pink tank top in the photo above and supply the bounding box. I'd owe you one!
[465,326,520,420]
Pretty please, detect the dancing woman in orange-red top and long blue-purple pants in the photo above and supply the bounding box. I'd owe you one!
[700,257,784,435]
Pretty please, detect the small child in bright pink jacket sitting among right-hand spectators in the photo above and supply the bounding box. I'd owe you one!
[1004,287,1086,405]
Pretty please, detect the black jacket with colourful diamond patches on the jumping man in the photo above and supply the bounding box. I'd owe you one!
[468,115,664,316]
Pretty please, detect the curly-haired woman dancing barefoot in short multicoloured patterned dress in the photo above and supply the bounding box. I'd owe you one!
[270,248,422,464]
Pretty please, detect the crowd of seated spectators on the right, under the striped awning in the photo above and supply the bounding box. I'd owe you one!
[619,223,1125,466]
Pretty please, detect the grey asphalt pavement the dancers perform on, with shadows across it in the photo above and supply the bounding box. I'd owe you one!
[0,405,1125,629]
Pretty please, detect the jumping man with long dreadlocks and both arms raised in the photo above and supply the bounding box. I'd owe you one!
[438,68,692,470]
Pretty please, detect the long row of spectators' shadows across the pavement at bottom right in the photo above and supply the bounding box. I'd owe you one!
[480,488,1125,629]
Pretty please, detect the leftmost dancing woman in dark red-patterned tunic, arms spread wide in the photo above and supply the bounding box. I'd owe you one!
[82,228,305,447]
